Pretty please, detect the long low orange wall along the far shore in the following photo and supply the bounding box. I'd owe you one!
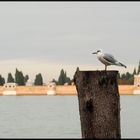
[0,85,140,96]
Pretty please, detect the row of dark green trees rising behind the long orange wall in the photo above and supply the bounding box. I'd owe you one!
[0,61,140,86]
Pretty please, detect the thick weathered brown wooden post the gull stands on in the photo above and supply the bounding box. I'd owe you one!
[74,70,121,138]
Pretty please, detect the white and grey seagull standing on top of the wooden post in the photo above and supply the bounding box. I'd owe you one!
[92,49,126,71]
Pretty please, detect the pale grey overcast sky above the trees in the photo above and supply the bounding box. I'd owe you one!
[0,1,140,83]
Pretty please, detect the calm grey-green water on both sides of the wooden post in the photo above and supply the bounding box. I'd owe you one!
[0,95,140,138]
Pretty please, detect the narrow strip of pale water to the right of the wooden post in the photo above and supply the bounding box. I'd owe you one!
[120,95,140,138]
